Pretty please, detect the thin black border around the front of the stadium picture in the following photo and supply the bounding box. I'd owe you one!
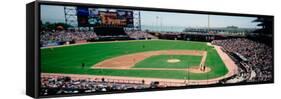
[27,1,275,98]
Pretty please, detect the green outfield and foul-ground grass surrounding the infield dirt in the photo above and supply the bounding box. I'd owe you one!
[40,40,228,80]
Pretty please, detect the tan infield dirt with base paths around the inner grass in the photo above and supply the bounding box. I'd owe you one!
[92,50,208,73]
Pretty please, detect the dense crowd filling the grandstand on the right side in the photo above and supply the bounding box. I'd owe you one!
[212,38,273,82]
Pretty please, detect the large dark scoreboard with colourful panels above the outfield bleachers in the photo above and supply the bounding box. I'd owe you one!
[77,7,134,27]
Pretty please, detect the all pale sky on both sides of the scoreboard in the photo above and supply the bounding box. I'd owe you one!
[41,5,258,28]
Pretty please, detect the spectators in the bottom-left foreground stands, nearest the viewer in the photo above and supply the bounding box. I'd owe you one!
[40,76,150,95]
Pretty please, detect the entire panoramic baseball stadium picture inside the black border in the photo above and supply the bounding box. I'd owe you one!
[39,4,274,96]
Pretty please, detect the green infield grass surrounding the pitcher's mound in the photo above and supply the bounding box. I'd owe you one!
[133,55,202,69]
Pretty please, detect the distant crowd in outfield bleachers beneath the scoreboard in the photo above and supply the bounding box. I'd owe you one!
[40,30,162,46]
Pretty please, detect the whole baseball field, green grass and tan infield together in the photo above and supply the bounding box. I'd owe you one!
[40,40,229,80]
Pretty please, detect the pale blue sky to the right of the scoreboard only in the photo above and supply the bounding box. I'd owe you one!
[141,11,258,28]
